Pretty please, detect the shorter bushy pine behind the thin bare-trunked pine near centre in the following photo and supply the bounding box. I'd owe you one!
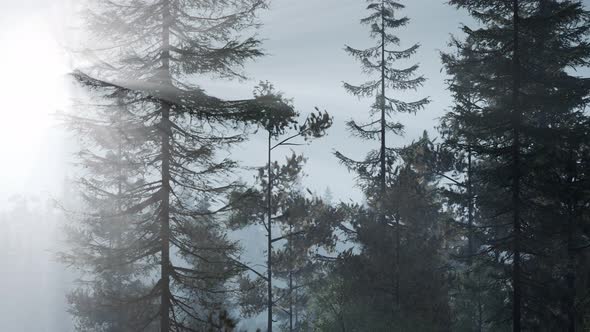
[232,154,334,331]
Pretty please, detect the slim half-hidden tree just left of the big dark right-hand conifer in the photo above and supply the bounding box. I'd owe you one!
[438,78,494,331]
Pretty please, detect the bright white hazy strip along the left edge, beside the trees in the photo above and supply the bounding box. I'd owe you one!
[0,0,71,332]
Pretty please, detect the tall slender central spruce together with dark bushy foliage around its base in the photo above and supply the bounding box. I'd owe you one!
[322,0,448,331]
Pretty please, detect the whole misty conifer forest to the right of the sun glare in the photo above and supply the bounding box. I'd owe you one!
[62,0,590,332]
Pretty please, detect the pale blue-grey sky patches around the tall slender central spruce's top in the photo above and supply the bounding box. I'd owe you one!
[208,0,466,200]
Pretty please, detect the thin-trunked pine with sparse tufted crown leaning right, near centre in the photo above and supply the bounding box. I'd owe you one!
[231,86,332,331]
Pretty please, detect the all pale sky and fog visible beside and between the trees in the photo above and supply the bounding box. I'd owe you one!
[0,0,590,332]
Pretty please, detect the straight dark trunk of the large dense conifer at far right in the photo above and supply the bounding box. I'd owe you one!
[512,0,522,332]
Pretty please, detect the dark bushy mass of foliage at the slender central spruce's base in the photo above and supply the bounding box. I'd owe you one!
[315,136,450,331]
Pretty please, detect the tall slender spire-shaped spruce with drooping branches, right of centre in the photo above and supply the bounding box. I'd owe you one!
[336,0,444,329]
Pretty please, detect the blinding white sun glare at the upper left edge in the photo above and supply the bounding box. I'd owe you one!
[0,16,66,193]
